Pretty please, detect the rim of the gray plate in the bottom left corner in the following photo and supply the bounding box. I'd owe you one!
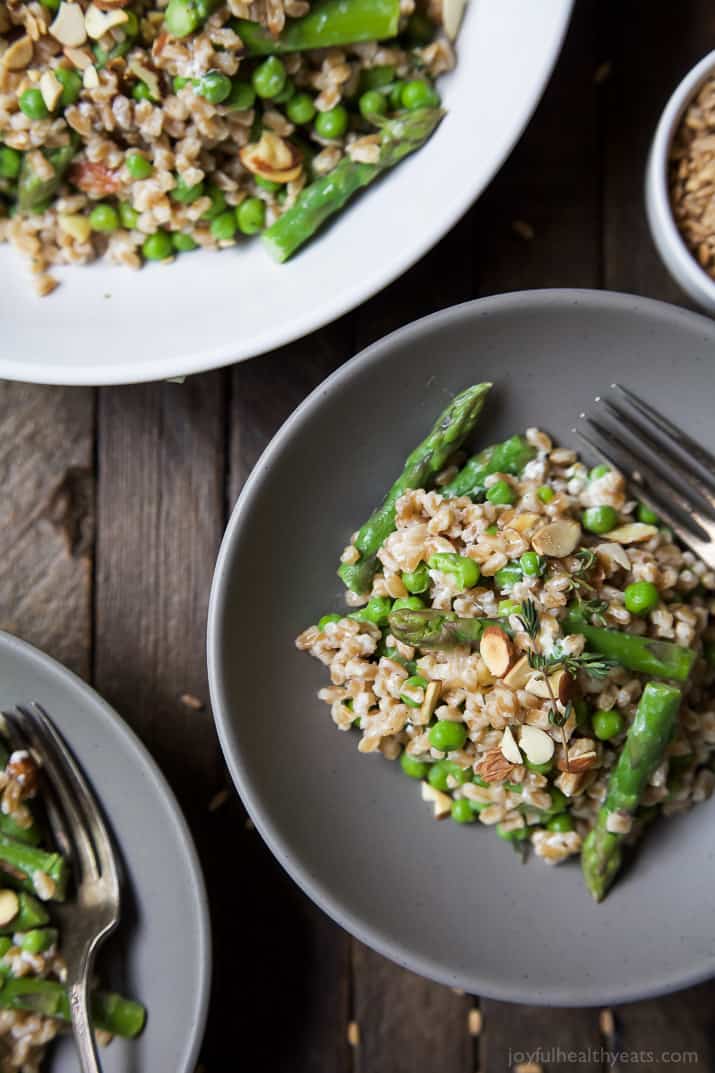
[0,631,211,1073]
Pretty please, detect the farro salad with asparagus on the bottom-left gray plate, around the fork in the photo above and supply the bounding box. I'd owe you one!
[0,736,146,1073]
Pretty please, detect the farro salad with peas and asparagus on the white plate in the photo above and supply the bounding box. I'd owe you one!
[0,0,457,294]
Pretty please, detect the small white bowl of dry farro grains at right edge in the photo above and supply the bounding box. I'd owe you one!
[645,52,715,314]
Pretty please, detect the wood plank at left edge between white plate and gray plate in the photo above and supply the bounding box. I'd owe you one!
[0,382,94,677]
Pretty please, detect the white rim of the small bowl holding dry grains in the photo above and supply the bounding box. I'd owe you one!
[645,49,715,307]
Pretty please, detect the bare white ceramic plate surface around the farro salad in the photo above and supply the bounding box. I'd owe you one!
[0,0,573,384]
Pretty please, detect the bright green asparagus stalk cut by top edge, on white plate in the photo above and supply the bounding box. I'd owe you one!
[232,0,399,56]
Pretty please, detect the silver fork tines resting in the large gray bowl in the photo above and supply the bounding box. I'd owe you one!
[573,384,715,569]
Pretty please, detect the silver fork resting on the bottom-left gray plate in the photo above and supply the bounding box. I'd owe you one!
[3,703,119,1073]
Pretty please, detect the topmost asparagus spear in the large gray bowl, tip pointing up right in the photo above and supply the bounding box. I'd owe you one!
[334,384,492,592]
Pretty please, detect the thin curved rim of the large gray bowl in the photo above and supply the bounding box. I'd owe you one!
[207,288,715,1006]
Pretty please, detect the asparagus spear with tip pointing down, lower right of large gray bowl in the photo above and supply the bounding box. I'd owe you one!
[581,681,681,901]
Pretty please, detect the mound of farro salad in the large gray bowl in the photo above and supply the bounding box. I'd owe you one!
[296,384,715,900]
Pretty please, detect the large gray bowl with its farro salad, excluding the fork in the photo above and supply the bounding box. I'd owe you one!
[208,291,715,1005]
